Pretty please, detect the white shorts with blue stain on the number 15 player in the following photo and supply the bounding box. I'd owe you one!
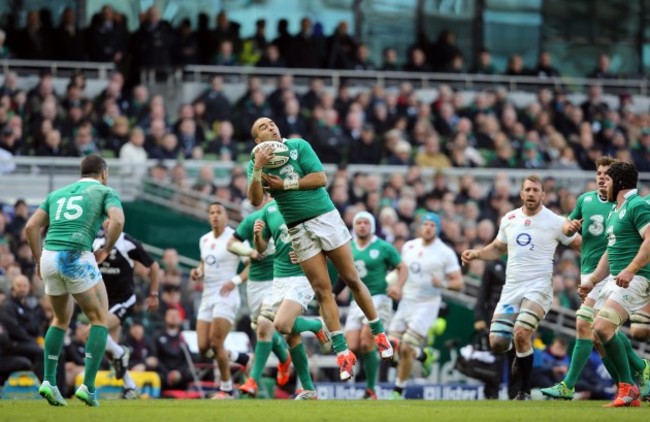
[40,250,102,296]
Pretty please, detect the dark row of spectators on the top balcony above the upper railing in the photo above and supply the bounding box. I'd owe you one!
[0,4,620,79]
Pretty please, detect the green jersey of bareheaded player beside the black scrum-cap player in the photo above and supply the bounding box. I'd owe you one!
[569,191,614,274]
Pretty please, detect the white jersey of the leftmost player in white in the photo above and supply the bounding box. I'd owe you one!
[199,226,240,296]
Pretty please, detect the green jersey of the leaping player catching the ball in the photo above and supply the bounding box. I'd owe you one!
[248,139,335,224]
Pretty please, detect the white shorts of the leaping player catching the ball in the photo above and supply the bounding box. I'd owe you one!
[289,210,352,262]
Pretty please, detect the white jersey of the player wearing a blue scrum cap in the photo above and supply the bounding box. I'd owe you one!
[402,237,460,300]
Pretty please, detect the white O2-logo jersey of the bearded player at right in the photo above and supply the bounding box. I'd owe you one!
[497,206,577,285]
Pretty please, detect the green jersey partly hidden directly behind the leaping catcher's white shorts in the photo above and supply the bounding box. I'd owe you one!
[261,200,305,278]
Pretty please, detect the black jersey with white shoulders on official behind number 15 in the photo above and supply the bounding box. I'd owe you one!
[93,233,154,307]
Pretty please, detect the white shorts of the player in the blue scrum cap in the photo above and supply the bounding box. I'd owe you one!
[388,296,442,338]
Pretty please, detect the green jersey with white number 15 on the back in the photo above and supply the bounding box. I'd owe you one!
[40,178,122,251]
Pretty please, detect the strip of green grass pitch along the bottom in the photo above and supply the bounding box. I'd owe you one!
[0,399,650,422]
